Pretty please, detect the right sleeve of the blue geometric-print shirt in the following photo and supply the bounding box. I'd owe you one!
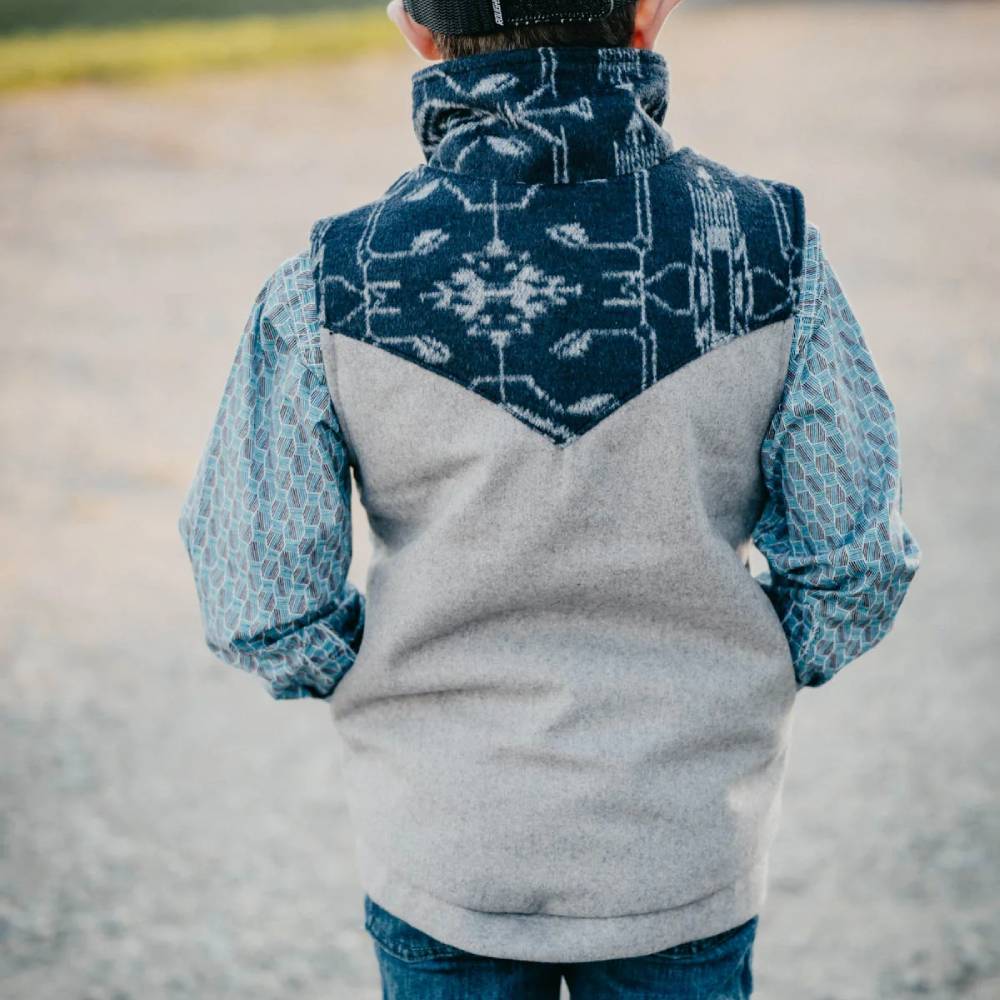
[753,224,920,688]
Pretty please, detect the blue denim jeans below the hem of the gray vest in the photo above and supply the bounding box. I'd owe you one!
[365,895,757,1000]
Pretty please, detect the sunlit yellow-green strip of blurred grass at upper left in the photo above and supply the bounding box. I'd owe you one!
[0,7,396,93]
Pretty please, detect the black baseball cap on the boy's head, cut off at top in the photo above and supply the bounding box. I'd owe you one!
[403,0,625,35]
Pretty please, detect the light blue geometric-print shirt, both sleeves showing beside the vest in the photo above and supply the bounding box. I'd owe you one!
[179,225,920,699]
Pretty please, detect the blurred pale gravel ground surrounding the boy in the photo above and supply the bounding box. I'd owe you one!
[0,3,1000,1000]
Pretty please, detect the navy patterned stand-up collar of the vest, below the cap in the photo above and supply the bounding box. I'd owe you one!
[412,46,673,184]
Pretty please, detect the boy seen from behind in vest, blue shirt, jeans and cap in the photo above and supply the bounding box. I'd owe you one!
[180,0,920,998]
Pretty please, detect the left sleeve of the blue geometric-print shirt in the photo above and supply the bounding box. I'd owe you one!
[178,254,365,699]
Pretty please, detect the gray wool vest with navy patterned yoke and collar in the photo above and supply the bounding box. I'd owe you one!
[312,49,805,962]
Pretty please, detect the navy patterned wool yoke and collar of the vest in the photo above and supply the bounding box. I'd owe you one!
[313,48,805,446]
